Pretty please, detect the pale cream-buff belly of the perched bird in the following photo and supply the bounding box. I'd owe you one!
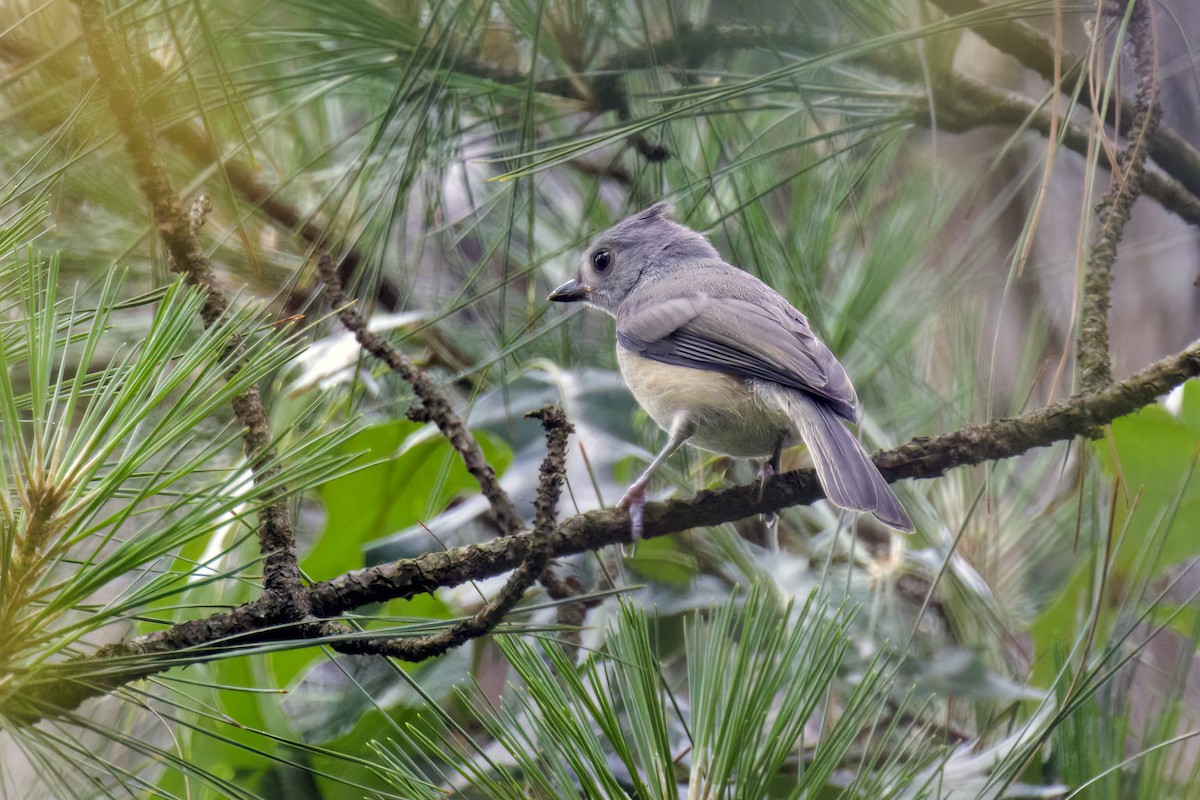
[617,347,798,458]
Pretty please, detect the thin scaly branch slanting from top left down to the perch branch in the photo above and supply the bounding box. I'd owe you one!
[76,0,305,599]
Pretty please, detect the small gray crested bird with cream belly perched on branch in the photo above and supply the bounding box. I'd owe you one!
[550,203,912,537]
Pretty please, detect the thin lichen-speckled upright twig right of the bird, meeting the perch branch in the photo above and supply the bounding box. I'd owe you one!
[1076,0,1158,392]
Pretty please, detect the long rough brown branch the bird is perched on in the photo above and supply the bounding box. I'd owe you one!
[16,342,1200,723]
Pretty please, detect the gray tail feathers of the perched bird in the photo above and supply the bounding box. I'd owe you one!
[764,386,912,531]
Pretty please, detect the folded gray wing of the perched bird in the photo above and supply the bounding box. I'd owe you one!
[617,291,858,422]
